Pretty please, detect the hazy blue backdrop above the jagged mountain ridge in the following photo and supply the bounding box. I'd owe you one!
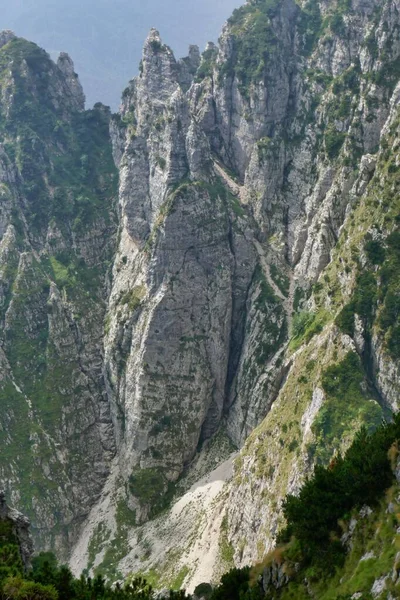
[0,0,243,108]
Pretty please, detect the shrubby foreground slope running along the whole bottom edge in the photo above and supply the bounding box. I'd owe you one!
[0,416,400,600]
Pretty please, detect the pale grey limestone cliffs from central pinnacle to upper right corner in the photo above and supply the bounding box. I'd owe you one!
[106,2,399,520]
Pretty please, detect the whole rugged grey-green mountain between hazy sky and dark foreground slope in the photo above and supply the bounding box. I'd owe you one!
[0,0,400,590]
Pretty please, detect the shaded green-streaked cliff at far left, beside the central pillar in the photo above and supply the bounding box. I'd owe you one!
[0,32,116,556]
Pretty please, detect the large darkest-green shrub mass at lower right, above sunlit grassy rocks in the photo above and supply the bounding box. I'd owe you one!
[281,415,400,571]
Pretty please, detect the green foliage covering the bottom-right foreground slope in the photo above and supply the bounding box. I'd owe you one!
[211,415,400,600]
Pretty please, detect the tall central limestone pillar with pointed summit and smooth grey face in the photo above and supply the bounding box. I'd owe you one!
[105,30,272,520]
